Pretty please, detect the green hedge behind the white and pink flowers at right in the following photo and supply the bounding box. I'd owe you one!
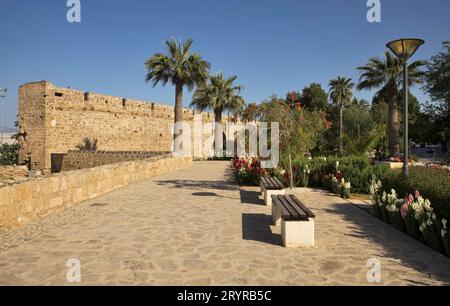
[381,167,450,218]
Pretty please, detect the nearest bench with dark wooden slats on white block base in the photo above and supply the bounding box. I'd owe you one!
[272,195,315,247]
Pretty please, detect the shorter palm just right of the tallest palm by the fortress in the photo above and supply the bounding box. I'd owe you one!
[191,73,244,156]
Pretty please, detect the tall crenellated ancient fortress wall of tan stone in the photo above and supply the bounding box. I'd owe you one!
[19,81,214,170]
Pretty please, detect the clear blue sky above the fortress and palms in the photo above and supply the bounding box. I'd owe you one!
[0,0,450,127]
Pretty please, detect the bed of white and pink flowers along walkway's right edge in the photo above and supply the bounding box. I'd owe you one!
[370,180,450,257]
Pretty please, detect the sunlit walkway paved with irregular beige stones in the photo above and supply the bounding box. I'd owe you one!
[0,162,450,285]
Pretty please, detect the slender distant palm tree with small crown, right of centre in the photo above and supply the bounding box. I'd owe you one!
[329,77,355,155]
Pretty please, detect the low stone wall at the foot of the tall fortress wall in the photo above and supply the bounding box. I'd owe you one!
[61,151,170,171]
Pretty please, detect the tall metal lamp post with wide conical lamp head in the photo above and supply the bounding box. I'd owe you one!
[386,38,425,178]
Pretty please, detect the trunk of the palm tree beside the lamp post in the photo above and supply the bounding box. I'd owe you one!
[387,88,400,157]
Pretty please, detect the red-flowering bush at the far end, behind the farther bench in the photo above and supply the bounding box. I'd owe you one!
[233,157,267,185]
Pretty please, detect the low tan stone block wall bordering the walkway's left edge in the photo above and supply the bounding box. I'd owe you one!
[0,157,192,231]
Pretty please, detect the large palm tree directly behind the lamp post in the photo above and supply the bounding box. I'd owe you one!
[357,51,425,157]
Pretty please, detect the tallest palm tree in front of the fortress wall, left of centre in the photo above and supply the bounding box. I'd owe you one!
[145,38,211,148]
